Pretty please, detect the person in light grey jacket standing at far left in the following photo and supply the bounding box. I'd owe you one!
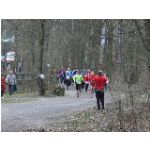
[6,71,17,95]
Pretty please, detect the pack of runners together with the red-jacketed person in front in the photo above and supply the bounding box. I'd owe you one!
[57,67,108,109]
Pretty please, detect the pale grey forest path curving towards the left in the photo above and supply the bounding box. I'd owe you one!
[1,86,111,132]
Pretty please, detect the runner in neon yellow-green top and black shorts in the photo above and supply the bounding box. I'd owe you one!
[73,71,83,97]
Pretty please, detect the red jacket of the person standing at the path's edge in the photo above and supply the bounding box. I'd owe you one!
[94,75,107,90]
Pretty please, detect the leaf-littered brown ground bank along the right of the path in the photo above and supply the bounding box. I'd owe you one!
[23,99,150,132]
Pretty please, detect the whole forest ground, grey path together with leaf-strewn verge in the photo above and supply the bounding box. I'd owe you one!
[1,86,150,132]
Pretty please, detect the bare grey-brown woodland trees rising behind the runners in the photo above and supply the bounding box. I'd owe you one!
[1,19,150,94]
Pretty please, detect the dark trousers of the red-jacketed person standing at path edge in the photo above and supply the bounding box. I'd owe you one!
[95,91,105,109]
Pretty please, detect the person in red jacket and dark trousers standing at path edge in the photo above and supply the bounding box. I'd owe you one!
[94,71,108,109]
